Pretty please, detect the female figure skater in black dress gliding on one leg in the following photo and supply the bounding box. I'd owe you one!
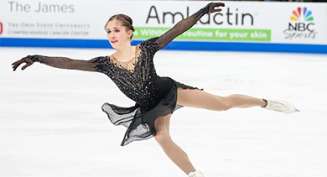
[12,2,297,177]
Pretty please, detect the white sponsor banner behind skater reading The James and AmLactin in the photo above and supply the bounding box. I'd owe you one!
[0,0,327,44]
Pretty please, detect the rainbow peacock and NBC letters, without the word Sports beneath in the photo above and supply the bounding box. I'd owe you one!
[288,7,315,32]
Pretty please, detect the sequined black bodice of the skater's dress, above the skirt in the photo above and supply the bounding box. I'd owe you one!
[97,40,160,106]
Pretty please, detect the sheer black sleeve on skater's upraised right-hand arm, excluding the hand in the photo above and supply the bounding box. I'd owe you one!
[155,6,209,48]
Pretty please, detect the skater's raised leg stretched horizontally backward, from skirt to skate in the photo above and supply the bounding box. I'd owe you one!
[177,88,266,111]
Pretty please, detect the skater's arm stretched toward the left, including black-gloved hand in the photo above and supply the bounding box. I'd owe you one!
[12,55,96,71]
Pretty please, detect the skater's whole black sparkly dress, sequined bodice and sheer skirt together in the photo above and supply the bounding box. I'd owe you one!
[92,38,202,146]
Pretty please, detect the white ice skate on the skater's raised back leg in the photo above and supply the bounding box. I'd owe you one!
[264,100,299,113]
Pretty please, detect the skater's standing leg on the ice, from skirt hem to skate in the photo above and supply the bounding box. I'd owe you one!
[155,114,195,174]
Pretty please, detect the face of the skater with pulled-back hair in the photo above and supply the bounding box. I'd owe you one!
[105,19,133,49]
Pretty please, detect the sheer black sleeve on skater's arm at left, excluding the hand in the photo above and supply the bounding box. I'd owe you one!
[35,55,97,71]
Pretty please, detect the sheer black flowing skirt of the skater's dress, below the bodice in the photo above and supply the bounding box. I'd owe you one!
[102,78,203,146]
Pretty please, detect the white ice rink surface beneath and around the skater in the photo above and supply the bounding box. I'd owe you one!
[0,48,327,177]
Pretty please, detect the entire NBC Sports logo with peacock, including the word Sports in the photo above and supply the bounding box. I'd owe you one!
[284,7,317,39]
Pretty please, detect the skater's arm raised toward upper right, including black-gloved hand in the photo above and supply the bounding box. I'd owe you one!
[155,2,225,48]
